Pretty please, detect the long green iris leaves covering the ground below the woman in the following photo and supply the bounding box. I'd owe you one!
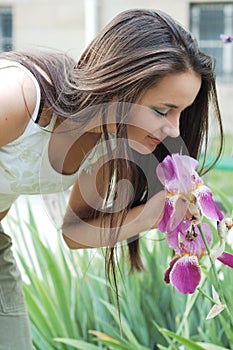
[5,200,233,350]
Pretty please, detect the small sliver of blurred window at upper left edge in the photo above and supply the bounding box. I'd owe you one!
[0,7,13,51]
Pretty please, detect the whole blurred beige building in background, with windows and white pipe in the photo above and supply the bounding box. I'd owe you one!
[0,0,233,134]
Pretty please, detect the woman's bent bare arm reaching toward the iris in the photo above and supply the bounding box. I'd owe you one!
[62,159,165,249]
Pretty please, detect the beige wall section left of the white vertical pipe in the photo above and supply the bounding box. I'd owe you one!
[0,0,84,56]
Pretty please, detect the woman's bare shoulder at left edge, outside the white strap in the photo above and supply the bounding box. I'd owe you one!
[0,67,36,147]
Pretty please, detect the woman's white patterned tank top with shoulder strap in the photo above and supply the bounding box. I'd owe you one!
[0,62,115,212]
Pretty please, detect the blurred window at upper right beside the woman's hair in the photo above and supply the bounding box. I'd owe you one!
[190,2,233,82]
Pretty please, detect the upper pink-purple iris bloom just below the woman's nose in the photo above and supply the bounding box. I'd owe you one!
[156,154,223,233]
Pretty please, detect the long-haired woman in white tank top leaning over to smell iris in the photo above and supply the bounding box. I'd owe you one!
[0,9,222,350]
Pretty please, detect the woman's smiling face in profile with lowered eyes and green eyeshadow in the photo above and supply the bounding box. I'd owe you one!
[127,71,201,154]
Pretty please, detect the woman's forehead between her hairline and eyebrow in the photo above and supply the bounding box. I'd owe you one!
[140,71,201,108]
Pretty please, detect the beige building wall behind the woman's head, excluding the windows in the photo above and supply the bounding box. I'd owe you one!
[0,0,233,133]
